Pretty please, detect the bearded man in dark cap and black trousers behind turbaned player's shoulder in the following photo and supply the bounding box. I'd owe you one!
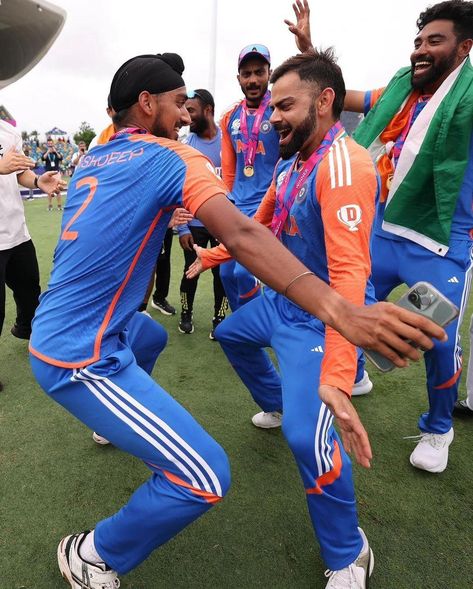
[177,88,228,340]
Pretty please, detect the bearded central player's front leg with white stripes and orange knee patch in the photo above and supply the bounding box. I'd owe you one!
[271,314,370,576]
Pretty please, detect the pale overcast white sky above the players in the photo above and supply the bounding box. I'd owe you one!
[0,0,429,138]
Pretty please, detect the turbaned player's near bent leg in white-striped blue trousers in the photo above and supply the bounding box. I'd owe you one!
[31,346,230,573]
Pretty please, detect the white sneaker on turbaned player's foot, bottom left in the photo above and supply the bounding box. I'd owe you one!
[57,531,120,589]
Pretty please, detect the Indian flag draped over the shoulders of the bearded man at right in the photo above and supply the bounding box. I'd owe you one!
[354,58,473,256]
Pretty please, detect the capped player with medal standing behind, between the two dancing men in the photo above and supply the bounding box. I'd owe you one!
[220,44,279,311]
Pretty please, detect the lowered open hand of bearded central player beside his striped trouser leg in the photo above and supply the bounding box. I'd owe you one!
[319,385,373,468]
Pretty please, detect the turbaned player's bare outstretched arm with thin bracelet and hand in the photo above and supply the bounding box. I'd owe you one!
[196,194,446,366]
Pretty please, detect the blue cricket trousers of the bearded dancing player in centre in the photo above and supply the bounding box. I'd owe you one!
[215,288,363,570]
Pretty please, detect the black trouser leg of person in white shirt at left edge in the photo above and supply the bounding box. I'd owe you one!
[5,240,41,339]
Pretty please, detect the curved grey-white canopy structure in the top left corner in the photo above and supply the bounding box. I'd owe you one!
[0,0,66,89]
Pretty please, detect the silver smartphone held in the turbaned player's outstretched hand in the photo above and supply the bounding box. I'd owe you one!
[363,282,459,372]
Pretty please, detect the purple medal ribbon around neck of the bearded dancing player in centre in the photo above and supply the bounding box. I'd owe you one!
[271,121,343,239]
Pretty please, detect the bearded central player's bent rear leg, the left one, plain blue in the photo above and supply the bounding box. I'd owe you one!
[215,291,282,413]
